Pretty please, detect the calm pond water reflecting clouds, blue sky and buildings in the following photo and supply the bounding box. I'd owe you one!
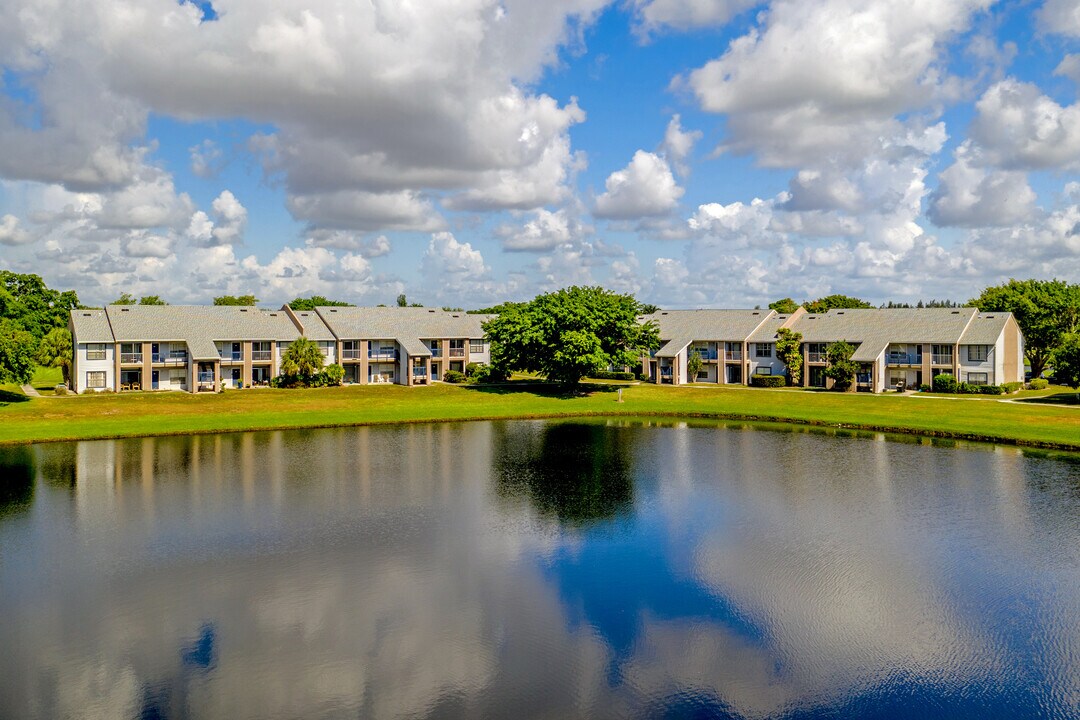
[0,422,1080,720]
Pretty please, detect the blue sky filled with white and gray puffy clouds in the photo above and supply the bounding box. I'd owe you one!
[0,0,1080,308]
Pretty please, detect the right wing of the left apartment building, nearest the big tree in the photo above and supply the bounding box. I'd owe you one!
[315,307,492,385]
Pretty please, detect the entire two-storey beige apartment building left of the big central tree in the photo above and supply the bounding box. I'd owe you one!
[68,305,490,392]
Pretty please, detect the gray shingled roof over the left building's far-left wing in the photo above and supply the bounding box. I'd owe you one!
[106,305,300,359]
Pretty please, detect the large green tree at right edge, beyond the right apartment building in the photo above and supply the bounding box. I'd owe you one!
[970,280,1080,378]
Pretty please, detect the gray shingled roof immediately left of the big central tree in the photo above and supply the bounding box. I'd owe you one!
[315,308,495,343]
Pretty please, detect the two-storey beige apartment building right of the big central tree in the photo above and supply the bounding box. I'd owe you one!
[643,308,1024,392]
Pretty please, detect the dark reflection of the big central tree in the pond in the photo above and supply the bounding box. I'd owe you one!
[492,422,634,526]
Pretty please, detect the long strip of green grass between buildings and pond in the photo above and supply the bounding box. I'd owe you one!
[0,383,1080,450]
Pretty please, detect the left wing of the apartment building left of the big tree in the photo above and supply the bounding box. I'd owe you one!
[68,305,335,392]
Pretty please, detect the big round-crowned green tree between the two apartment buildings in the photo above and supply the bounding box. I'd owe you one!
[483,287,660,384]
